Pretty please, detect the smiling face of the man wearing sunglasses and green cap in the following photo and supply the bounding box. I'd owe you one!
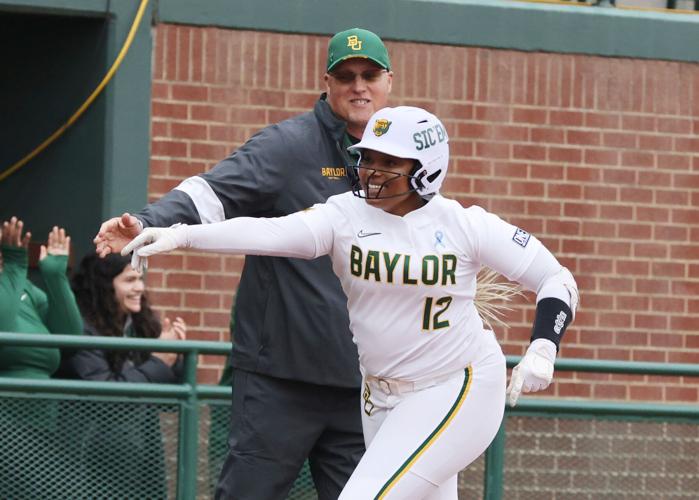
[325,57,393,137]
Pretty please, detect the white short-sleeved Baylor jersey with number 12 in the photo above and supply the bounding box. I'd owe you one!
[301,193,541,380]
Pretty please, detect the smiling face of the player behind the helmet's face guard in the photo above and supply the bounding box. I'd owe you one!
[358,149,424,216]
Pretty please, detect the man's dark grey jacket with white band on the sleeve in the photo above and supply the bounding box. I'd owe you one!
[137,95,360,387]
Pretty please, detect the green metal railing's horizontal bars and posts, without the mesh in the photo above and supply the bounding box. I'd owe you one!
[0,333,699,500]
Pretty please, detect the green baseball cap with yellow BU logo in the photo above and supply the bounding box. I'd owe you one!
[327,28,391,71]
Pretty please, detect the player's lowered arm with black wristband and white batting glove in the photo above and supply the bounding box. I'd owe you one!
[507,247,578,406]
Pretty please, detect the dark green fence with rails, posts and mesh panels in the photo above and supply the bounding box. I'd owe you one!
[0,333,699,500]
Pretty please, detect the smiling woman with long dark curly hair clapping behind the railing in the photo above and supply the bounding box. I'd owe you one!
[58,254,187,498]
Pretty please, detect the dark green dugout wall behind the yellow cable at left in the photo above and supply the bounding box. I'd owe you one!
[0,0,151,264]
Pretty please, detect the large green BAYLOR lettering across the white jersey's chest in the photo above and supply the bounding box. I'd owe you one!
[349,245,456,286]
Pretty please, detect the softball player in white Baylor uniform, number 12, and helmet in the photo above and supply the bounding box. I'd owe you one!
[123,107,578,500]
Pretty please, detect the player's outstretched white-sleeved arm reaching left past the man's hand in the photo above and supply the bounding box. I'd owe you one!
[121,213,321,268]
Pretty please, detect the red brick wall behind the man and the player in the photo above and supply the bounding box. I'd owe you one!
[148,24,699,401]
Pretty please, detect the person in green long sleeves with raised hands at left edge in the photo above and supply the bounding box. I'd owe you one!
[0,217,83,498]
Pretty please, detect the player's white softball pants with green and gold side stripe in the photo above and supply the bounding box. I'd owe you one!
[340,331,506,500]
